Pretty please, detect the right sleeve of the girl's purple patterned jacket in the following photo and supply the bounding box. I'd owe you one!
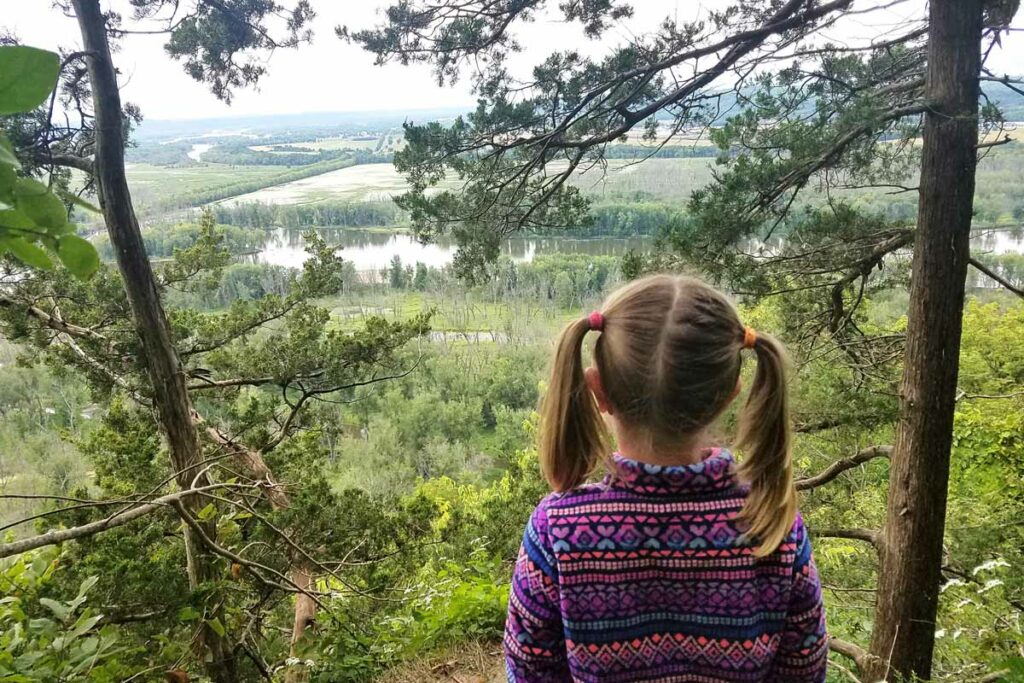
[768,514,828,683]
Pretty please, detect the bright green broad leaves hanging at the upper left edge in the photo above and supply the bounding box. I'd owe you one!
[0,45,99,278]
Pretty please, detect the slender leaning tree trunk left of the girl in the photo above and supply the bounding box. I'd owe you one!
[73,0,238,683]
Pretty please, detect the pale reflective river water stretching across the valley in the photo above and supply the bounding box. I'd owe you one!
[255,228,1024,271]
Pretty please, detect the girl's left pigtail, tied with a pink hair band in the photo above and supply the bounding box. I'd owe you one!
[539,318,606,492]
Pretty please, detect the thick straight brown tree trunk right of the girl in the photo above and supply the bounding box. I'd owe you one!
[865,0,984,681]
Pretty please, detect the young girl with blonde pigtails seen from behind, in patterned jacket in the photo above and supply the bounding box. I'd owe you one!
[505,275,827,683]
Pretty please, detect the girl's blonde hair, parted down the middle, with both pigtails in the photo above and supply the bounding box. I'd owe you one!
[540,275,797,554]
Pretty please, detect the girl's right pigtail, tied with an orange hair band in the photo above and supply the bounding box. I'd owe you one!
[737,334,797,557]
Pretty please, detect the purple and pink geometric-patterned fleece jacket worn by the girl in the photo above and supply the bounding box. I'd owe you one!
[505,449,828,683]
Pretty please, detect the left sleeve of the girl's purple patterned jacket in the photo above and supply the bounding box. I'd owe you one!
[504,502,572,683]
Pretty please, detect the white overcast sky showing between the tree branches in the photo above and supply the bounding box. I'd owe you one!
[0,0,1024,119]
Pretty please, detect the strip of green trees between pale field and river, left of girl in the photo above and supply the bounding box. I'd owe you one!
[213,202,403,229]
